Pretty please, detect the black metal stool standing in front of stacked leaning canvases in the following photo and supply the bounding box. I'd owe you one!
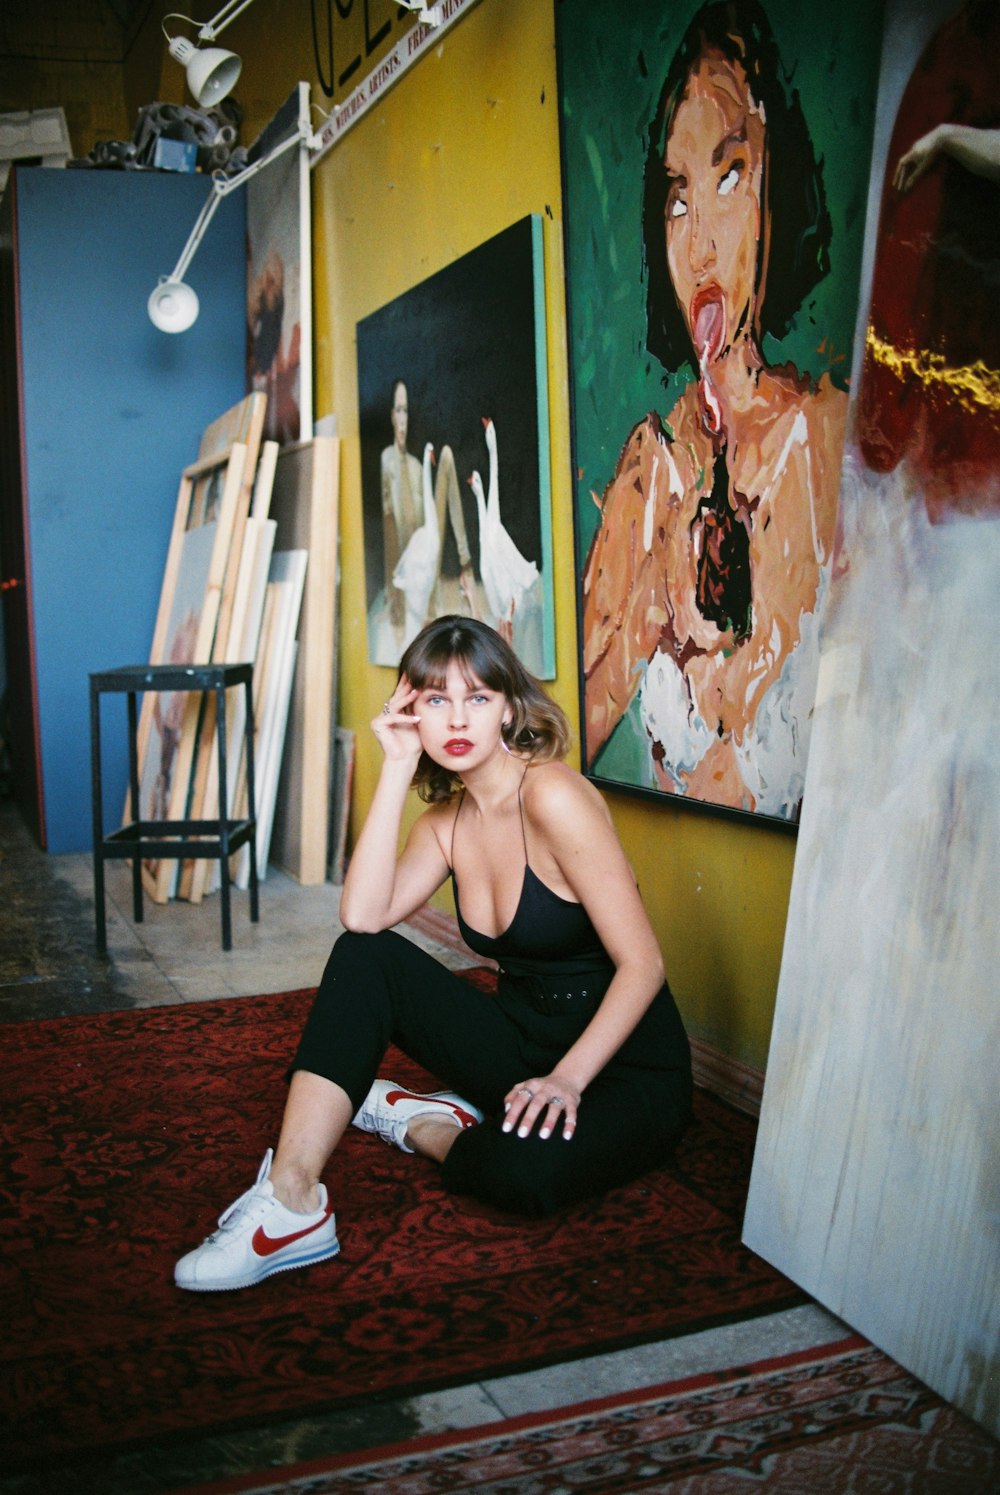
[90,664,259,955]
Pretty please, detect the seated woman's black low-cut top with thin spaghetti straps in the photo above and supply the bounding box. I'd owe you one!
[451,770,614,976]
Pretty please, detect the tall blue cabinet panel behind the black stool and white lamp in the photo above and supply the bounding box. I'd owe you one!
[18,169,245,852]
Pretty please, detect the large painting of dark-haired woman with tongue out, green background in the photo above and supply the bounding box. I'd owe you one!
[556,0,880,824]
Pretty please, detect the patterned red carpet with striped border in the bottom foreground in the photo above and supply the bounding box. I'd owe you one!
[165,1335,1000,1495]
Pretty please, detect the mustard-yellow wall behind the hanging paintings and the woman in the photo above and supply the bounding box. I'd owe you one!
[109,0,795,1069]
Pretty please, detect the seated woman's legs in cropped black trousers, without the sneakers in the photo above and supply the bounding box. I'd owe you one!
[272,931,691,1215]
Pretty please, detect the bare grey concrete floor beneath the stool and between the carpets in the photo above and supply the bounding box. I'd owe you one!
[0,801,849,1495]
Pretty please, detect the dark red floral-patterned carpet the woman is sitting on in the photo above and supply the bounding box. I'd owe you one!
[0,972,804,1468]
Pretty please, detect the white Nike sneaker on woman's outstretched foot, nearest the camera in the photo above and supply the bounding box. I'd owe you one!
[173,1148,341,1293]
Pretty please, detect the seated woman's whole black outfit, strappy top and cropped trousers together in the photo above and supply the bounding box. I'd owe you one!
[291,783,691,1215]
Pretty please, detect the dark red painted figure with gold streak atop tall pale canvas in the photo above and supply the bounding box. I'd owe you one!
[858,0,1000,523]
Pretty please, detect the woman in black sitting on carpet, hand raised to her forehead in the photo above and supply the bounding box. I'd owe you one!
[175,617,691,1292]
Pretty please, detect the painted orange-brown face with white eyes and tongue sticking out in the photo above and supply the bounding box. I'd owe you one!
[664,54,764,372]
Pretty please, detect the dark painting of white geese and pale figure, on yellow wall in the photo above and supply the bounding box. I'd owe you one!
[357,218,555,679]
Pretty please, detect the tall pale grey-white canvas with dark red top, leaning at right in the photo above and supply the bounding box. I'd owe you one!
[744,0,1000,1441]
